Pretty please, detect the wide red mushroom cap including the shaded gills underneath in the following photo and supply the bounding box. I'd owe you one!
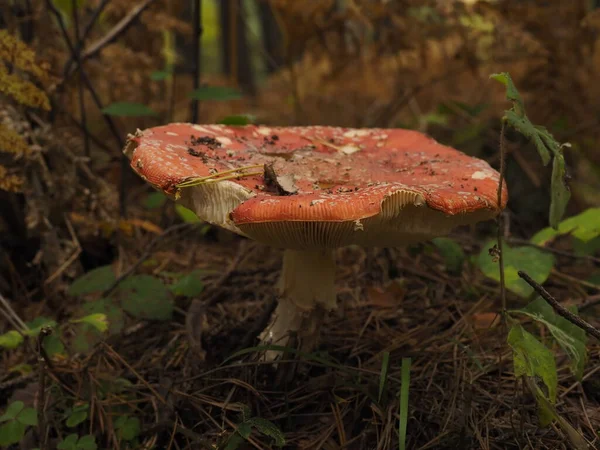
[125,123,508,247]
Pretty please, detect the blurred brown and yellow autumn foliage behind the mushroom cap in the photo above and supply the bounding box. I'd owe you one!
[0,0,600,300]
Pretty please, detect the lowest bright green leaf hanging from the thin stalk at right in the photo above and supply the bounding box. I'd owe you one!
[508,323,558,403]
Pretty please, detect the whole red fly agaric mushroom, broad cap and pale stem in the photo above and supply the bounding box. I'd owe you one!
[124,123,508,358]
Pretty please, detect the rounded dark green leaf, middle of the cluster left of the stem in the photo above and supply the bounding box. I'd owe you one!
[117,275,173,320]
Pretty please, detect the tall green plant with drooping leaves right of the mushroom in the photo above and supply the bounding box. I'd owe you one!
[488,73,599,449]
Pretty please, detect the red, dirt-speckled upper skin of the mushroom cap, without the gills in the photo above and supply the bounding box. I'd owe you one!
[129,123,508,223]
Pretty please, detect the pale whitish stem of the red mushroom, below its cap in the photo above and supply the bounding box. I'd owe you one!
[260,250,337,361]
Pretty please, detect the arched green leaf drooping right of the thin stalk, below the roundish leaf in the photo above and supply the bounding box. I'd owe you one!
[511,297,587,380]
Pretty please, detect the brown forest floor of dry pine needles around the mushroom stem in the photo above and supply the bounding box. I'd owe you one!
[0,220,600,449]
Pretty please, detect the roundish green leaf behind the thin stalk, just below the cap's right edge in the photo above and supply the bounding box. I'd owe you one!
[477,241,554,297]
